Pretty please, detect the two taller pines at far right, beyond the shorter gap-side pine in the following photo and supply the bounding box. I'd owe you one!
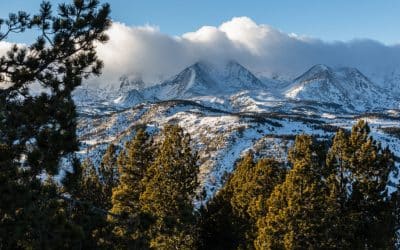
[255,121,399,249]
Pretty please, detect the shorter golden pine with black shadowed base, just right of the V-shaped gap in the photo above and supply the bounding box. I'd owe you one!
[200,153,286,249]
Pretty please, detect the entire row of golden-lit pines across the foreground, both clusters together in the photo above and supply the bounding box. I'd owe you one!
[49,121,399,249]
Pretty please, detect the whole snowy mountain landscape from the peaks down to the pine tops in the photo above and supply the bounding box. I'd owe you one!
[74,61,400,202]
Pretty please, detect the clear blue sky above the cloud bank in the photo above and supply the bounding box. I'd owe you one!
[0,0,400,44]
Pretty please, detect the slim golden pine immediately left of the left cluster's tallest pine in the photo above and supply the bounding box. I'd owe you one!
[109,128,154,249]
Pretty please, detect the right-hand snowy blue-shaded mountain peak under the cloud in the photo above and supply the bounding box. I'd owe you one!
[284,65,399,111]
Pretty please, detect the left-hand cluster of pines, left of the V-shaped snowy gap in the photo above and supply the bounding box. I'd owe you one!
[60,125,199,249]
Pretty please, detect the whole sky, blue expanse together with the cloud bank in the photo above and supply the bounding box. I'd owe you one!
[0,0,400,84]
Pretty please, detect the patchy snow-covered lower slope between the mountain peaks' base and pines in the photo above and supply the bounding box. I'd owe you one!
[78,100,400,201]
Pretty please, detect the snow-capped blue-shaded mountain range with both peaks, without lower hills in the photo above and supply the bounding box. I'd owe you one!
[115,61,399,112]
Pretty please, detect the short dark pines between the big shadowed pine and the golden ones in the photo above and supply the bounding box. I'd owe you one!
[63,148,117,249]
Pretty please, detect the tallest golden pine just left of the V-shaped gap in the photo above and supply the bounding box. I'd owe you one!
[140,125,199,249]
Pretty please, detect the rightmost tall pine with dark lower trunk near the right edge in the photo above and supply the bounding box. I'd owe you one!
[349,120,394,248]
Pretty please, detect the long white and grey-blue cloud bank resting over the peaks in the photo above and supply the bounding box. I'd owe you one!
[0,17,400,87]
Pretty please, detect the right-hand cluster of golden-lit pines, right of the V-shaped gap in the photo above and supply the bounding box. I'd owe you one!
[200,121,399,249]
